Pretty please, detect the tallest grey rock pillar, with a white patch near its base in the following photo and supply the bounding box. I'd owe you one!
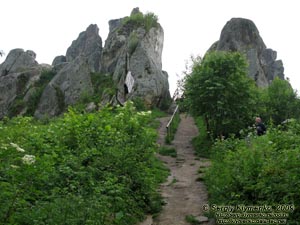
[101,8,170,107]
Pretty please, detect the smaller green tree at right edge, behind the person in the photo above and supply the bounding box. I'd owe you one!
[261,77,300,125]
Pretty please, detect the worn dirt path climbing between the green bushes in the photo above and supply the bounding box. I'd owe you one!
[141,115,212,225]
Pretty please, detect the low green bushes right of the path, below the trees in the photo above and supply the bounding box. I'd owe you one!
[205,121,300,224]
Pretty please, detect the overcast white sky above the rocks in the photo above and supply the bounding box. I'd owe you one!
[0,0,300,93]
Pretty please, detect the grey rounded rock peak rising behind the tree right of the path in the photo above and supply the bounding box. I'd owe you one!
[209,18,284,86]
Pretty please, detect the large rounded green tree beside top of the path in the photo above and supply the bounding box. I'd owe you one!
[184,51,256,137]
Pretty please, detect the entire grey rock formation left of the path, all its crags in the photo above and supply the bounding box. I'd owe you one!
[0,8,170,119]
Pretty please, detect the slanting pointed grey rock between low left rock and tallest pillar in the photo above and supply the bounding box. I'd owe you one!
[34,25,102,118]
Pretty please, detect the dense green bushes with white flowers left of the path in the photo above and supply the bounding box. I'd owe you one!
[0,103,167,225]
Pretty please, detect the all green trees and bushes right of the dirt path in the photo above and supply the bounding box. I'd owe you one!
[183,52,300,225]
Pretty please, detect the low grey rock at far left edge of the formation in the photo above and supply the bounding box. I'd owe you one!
[0,49,49,119]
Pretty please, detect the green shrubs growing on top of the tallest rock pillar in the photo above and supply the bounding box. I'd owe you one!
[122,12,158,32]
